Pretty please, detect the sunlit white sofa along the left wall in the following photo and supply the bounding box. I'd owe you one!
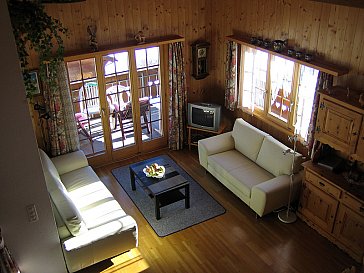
[39,149,138,272]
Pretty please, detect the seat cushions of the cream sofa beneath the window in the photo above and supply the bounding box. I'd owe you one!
[208,150,274,197]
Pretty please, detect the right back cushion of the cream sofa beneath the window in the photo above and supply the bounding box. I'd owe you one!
[256,136,302,176]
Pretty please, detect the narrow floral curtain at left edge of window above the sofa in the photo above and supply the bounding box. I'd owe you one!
[225,41,238,111]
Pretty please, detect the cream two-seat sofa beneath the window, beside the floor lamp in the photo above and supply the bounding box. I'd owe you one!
[198,118,302,216]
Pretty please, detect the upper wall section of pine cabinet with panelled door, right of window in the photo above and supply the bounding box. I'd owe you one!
[315,94,362,155]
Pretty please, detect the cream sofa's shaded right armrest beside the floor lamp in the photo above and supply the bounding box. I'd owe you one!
[250,171,303,216]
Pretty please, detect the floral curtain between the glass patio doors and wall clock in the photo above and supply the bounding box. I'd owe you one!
[168,42,187,150]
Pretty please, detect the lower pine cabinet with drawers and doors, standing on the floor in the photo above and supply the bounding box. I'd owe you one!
[298,162,364,262]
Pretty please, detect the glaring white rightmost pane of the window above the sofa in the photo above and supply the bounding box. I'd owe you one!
[295,65,319,140]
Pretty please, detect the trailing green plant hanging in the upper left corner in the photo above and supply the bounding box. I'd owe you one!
[8,0,68,98]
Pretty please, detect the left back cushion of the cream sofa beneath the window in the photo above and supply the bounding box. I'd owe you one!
[232,118,269,161]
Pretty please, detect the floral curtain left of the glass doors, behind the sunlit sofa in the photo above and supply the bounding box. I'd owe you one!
[43,62,80,156]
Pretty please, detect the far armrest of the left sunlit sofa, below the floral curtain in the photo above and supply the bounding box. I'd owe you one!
[51,150,88,175]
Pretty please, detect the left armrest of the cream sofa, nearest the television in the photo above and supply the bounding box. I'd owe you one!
[198,132,235,169]
